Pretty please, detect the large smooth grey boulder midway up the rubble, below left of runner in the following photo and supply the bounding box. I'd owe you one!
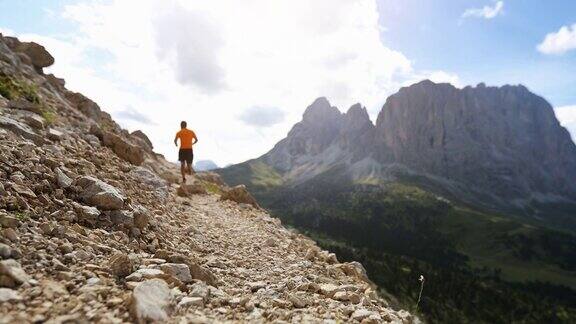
[74,176,124,210]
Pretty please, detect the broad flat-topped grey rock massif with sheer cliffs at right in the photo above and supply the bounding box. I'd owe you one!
[376,81,576,205]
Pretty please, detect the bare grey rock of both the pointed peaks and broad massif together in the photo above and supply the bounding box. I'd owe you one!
[250,81,576,213]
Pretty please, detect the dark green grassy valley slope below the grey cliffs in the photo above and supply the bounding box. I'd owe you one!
[220,160,576,322]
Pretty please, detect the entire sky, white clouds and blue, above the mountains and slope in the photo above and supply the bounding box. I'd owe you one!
[0,0,576,165]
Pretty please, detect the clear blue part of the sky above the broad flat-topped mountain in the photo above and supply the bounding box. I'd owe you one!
[378,0,576,106]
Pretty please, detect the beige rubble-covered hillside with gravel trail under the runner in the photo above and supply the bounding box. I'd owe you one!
[0,35,418,323]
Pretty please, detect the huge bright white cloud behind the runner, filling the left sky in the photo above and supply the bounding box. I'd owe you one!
[0,0,457,165]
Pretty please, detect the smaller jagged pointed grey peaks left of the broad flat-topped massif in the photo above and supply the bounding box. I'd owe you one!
[261,98,375,182]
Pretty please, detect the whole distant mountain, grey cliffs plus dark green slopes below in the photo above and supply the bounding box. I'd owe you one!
[217,81,576,323]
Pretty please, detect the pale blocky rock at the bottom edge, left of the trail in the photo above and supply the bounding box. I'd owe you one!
[130,279,170,323]
